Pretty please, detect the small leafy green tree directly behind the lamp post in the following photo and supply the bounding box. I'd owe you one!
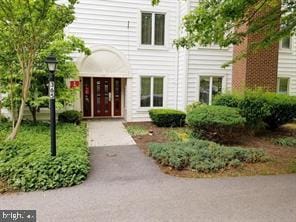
[27,35,90,123]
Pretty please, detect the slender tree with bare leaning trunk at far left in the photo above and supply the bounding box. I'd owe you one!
[0,0,77,140]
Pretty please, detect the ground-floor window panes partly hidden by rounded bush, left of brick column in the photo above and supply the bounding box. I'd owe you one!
[199,76,223,105]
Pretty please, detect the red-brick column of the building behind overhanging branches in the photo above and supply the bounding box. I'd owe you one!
[232,2,279,92]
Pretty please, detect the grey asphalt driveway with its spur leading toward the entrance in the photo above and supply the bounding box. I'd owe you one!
[0,146,296,222]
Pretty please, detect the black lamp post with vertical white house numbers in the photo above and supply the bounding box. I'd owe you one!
[45,55,58,156]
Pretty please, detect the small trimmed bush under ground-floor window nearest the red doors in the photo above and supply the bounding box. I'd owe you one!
[149,109,186,127]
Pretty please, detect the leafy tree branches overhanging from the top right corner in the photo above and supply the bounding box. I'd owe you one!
[152,0,296,56]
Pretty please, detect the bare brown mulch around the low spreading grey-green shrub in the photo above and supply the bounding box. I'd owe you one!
[126,122,296,178]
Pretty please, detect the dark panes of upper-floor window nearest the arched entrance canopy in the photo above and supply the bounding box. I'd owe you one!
[141,12,165,46]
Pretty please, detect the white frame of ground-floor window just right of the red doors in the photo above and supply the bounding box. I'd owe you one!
[139,75,166,108]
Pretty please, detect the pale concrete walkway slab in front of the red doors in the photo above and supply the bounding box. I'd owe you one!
[87,120,135,147]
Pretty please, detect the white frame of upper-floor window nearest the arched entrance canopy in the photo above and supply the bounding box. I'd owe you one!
[138,9,169,50]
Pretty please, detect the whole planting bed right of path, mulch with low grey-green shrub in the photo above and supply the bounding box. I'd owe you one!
[126,122,296,178]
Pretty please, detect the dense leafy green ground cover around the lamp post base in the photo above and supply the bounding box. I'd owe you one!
[0,123,90,192]
